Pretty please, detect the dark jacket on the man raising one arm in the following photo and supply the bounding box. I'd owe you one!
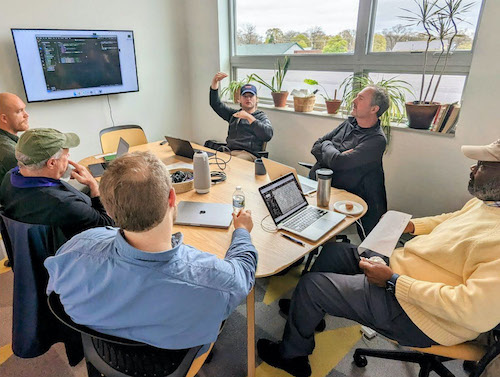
[210,88,273,155]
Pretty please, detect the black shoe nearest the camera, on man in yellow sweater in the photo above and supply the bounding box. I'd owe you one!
[257,339,311,377]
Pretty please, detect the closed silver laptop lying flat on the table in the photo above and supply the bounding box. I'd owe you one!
[175,201,233,228]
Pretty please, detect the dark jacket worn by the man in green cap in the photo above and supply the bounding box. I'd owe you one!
[0,169,114,239]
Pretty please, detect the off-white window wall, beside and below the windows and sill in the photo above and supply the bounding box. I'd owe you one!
[185,0,500,216]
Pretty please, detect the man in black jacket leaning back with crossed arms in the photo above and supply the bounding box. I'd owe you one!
[309,85,389,236]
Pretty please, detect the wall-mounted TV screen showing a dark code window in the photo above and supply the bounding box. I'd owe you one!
[11,29,139,102]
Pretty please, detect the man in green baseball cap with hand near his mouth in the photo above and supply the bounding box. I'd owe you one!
[0,128,114,241]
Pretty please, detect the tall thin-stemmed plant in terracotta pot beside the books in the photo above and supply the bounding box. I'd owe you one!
[400,0,473,129]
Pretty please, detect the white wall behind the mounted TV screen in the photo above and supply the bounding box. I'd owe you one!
[0,0,191,161]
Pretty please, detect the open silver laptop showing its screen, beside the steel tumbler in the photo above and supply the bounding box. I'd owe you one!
[259,173,345,242]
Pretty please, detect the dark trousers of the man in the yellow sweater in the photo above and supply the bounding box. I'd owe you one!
[280,243,437,358]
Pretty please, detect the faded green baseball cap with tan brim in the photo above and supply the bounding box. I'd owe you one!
[16,128,80,164]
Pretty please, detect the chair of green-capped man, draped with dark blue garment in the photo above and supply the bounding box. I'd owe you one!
[0,212,83,366]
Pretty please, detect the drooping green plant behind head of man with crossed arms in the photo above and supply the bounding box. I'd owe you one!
[340,74,412,143]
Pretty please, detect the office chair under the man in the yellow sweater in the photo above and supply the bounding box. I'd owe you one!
[353,326,500,377]
